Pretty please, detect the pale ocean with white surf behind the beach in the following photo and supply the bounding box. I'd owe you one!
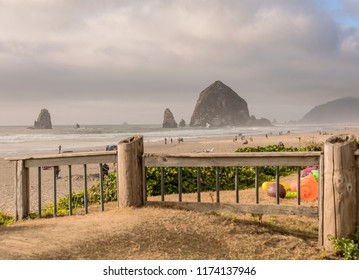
[0,124,358,157]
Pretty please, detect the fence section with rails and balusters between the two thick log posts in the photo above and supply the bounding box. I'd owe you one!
[143,152,323,217]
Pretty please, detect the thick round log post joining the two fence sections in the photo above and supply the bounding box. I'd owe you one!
[117,135,144,207]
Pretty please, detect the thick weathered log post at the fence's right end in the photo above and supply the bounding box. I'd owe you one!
[323,135,359,251]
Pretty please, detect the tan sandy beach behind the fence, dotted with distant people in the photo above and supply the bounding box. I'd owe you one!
[0,126,359,214]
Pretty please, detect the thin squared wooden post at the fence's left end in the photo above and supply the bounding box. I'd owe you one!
[15,160,30,220]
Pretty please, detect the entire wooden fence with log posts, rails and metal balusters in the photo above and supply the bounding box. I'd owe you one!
[4,135,359,249]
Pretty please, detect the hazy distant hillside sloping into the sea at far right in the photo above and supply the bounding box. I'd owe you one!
[299,97,359,123]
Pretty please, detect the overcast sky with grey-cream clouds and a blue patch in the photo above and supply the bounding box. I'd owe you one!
[0,0,359,125]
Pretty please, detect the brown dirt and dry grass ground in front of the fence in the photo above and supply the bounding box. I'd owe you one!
[0,203,320,260]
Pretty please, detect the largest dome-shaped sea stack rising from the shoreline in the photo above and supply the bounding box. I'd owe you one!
[190,81,250,127]
